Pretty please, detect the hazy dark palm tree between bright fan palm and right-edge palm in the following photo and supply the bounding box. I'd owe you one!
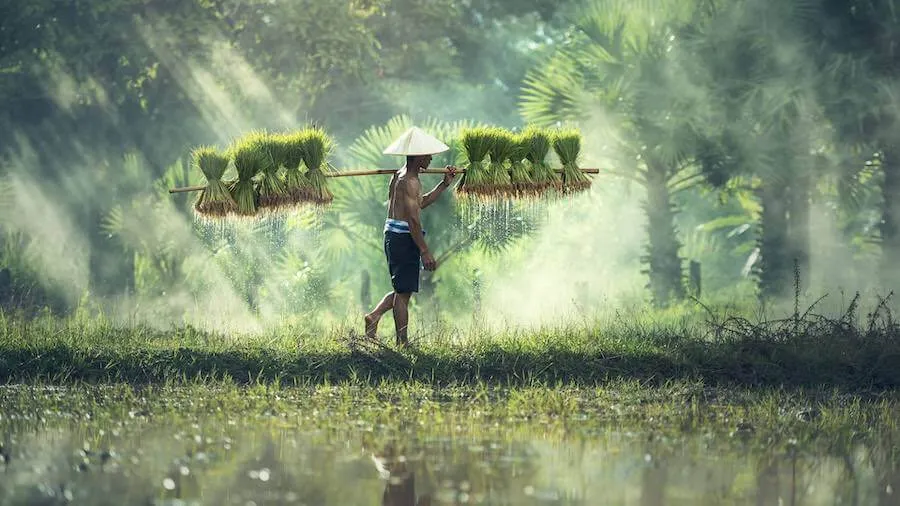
[684,0,826,298]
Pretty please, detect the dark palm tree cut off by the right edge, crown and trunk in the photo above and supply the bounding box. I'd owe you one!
[801,0,900,283]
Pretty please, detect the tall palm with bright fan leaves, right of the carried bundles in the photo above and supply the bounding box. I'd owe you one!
[521,0,703,306]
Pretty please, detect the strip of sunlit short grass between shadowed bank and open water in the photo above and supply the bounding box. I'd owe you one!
[0,377,900,435]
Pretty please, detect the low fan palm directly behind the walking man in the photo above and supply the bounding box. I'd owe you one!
[322,115,537,314]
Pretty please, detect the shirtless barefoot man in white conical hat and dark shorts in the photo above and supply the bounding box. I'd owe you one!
[365,127,456,346]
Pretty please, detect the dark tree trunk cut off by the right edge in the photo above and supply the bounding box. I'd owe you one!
[880,145,900,286]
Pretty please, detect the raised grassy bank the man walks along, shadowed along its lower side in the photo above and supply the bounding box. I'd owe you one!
[0,300,900,391]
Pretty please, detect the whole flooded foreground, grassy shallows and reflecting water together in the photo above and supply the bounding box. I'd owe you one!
[0,387,900,506]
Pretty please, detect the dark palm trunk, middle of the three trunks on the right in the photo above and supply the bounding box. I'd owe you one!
[757,184,793,299]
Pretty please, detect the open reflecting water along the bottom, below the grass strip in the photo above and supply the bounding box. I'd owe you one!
[0,420,900,506]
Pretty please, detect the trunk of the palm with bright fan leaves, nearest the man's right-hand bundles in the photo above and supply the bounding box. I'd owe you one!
[642,163,685,307]
